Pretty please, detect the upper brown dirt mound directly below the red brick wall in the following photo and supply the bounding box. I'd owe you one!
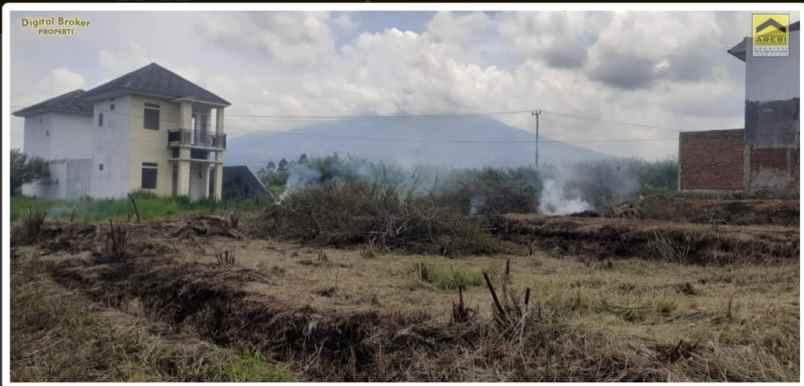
[605,195,800,226]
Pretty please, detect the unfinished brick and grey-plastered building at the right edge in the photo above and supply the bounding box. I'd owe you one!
[679,22,801,192]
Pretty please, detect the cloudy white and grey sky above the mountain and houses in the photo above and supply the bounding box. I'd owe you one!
[10,11,798,159]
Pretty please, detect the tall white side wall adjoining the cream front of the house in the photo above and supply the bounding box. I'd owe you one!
[90,97,132,198]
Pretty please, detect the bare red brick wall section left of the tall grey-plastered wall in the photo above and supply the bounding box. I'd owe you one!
[678,129,745,190]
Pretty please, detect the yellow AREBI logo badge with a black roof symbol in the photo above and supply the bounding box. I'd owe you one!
[751,13,790,56]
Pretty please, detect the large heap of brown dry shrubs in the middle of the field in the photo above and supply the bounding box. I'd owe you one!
[261,181,500,256]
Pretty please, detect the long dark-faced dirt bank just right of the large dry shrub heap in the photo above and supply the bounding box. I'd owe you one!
[492,215,799,264]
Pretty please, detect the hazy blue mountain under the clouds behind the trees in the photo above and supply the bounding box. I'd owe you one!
[225,116,610,170]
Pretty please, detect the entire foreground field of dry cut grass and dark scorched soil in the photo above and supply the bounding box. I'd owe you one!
[12,211,800,381]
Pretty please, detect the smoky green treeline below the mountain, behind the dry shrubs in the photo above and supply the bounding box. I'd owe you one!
[257,154,678,214]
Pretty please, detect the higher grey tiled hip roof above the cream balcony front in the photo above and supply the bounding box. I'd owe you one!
[85,63,230,106]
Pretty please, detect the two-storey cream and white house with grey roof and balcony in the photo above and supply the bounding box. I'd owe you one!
[14,63,230,200]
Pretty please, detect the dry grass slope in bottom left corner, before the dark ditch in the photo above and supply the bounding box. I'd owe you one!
[11,250,300,382]
